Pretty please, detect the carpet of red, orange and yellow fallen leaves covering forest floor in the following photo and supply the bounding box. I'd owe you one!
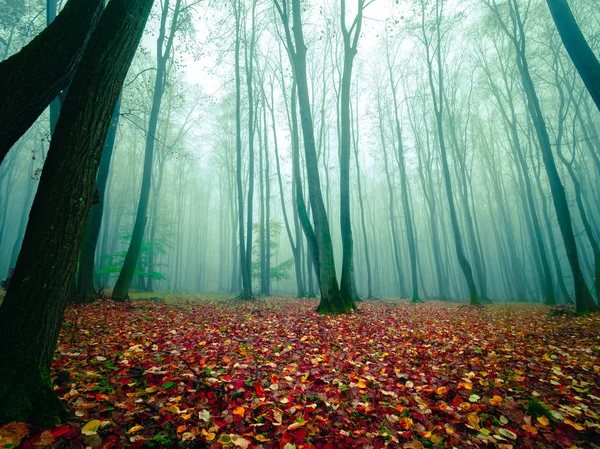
[0,298,600,449]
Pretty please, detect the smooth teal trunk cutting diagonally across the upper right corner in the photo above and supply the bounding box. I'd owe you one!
[546,0,600,111]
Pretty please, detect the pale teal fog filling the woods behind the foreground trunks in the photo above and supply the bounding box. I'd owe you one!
[0,0,600,302]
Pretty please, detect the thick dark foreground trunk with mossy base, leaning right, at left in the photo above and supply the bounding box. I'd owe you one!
[0,0,152,426]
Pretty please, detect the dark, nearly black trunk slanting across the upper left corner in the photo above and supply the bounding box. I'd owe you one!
[0,0,104,164]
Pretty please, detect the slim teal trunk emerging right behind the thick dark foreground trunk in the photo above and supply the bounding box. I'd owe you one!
[76,96,121,303]
